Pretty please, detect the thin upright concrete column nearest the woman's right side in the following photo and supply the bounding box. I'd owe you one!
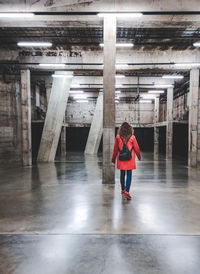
[154,97,160,160]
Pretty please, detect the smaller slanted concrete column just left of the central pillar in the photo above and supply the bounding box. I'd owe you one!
[85,92,103,155]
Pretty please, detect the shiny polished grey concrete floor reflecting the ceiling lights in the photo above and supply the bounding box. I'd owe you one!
[0,153,200,274]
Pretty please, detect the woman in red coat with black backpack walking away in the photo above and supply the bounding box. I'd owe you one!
[112,122,141,200]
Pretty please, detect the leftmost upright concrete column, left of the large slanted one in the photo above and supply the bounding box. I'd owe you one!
[21,69,32,166]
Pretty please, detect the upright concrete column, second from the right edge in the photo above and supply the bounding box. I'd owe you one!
[166,85,173,158]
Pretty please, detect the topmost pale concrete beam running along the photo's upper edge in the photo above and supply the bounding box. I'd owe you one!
[0,0,199,12]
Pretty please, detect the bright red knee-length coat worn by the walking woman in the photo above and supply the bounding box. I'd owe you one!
[112,135,141,170]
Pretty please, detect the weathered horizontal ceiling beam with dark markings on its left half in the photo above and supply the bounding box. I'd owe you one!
[0,47,200,70]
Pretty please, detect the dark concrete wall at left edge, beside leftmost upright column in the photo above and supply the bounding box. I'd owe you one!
[0,80,21,165]
